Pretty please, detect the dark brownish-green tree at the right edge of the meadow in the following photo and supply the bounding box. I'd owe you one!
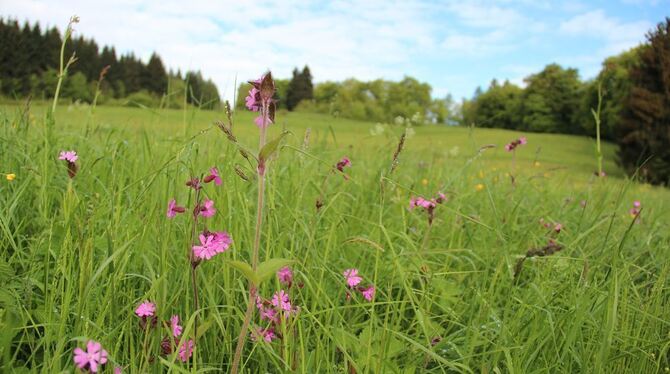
[617,18,670,185]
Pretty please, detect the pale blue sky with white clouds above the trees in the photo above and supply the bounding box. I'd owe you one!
[0,0,670,100]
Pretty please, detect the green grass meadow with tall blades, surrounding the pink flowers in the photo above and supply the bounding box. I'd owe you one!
[0,103,670,373]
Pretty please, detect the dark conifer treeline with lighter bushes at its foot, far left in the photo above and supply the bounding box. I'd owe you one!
[0,18,220,108]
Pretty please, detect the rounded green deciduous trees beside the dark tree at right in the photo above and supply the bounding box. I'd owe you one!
[461,51,639,140]
